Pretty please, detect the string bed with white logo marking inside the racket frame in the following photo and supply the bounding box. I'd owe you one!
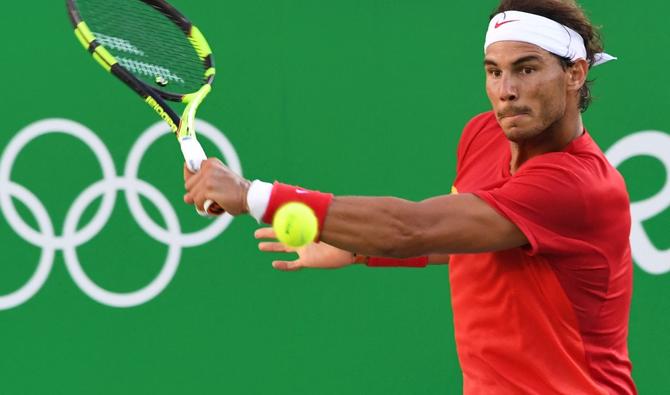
[76,0,205,94]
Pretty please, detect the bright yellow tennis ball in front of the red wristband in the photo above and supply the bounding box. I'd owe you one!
[272,202,319,248]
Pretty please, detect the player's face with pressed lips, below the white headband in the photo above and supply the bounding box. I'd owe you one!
[484,41,568,143]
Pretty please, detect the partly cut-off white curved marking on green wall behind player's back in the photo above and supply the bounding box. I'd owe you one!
[607,130,670,275]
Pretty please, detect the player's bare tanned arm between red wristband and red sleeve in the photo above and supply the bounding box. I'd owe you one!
[321,194,528,258]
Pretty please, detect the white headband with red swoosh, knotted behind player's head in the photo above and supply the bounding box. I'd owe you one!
[484,11,616,66]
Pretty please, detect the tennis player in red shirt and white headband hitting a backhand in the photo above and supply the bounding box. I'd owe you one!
[184,0,636,395]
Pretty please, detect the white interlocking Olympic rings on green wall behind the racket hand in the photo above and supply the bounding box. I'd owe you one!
[0,119,242,310]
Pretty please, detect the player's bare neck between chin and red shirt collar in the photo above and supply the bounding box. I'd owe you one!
[510,114,584,174]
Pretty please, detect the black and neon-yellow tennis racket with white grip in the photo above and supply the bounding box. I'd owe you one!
[67,0,223,215]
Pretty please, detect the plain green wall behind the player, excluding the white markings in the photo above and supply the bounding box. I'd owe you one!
[0,0,670,394]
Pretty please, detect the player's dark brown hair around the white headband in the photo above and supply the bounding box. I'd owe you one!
[491,0,603,112]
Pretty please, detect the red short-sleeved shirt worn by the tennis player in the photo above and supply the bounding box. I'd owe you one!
[449,112,636,395]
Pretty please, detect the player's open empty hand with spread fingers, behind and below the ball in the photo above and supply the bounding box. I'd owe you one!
[254,228,354,271]
